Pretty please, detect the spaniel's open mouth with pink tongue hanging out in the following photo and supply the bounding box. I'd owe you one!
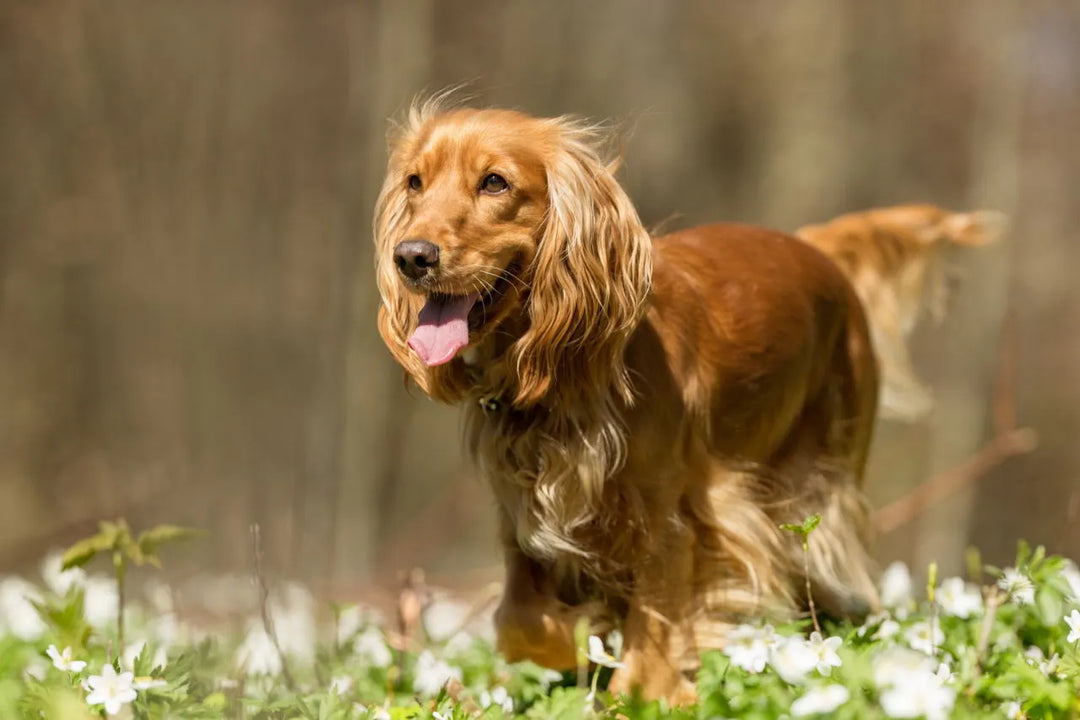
[408,261,521,367]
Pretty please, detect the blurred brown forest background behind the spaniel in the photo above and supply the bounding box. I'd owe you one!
[0,0,1080,595]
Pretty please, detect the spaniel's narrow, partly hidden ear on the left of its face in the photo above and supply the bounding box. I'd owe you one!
[374,102,465,403]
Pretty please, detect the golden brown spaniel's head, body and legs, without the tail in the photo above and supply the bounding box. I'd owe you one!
[375,105,878,702]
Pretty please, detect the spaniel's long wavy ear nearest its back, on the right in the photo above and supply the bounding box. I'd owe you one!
[511,120,652,407]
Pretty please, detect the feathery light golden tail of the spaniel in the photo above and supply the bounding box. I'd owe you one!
[795,205,1007,422]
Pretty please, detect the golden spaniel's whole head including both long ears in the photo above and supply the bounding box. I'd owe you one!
[375,105,651,407]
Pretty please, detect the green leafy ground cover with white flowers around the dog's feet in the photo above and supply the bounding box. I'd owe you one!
[0,524,1080,720]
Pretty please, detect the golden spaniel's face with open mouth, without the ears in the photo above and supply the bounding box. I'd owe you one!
[379,110,553,367]
